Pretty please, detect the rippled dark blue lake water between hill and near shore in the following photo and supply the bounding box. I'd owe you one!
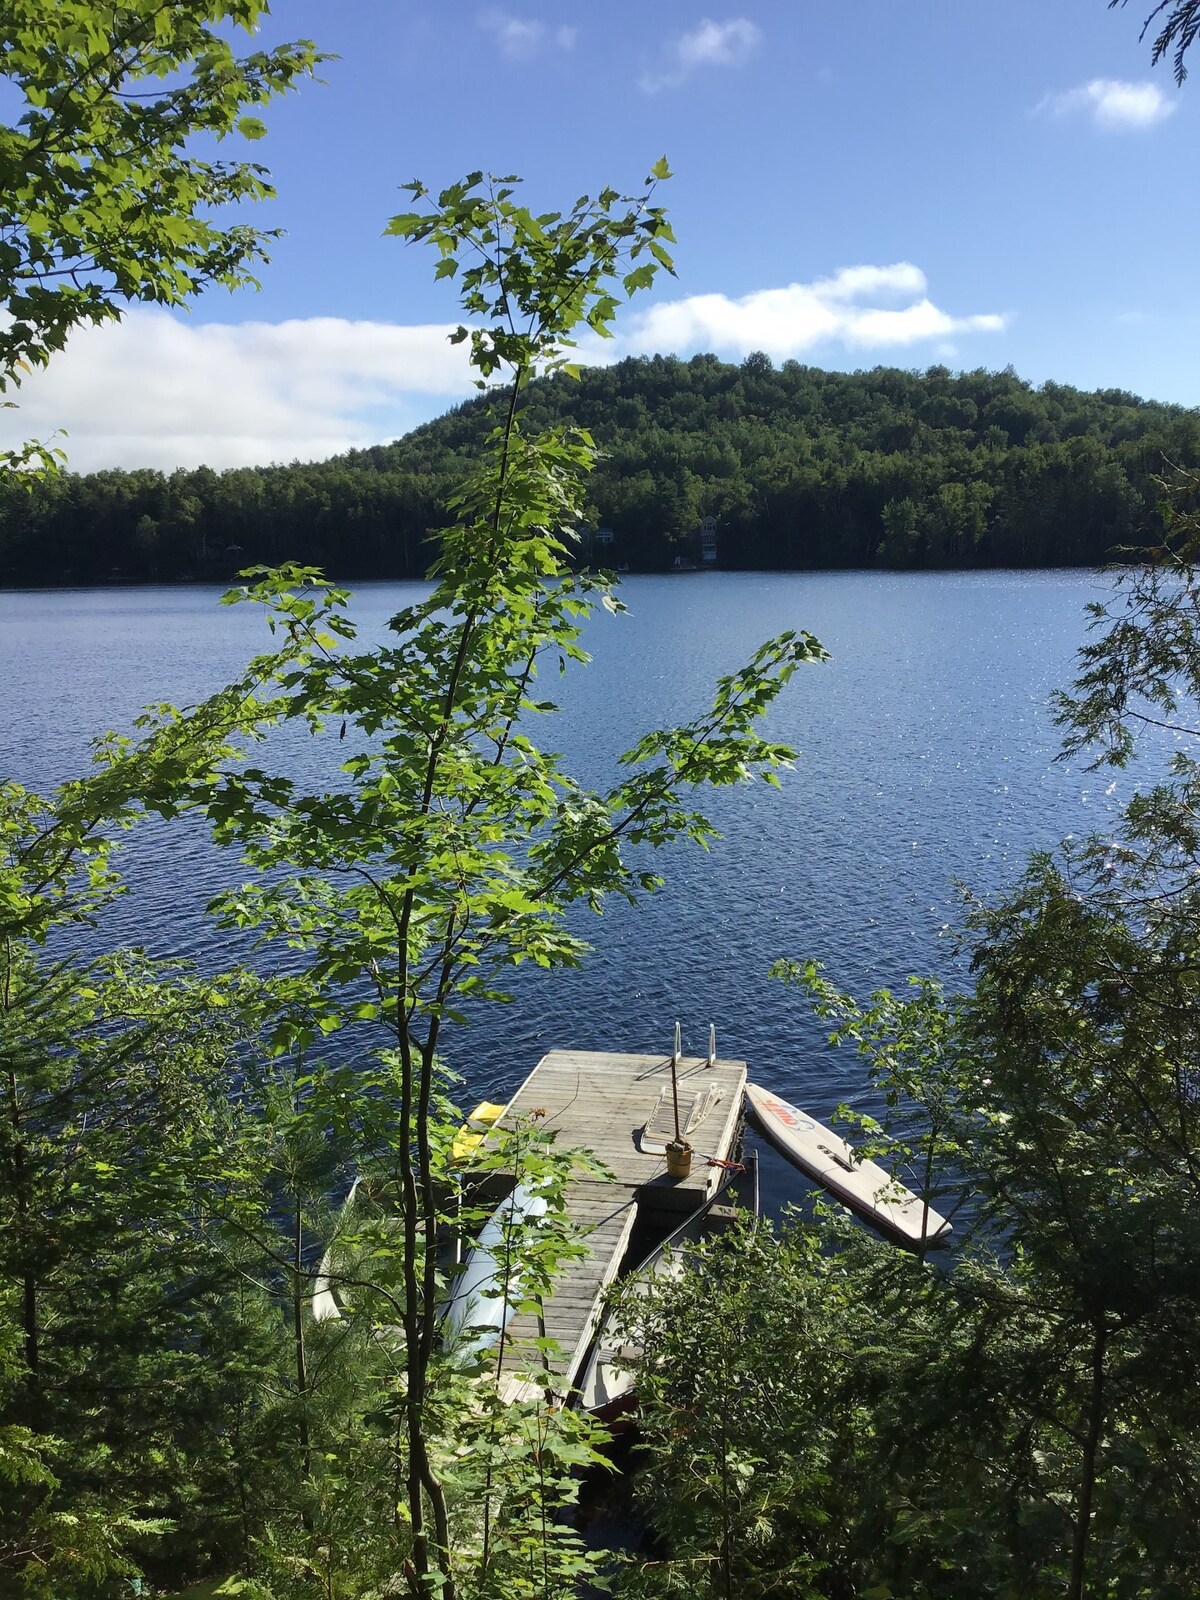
[0,571,1133,1200]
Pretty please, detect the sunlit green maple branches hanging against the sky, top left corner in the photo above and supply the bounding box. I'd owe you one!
[0,0,323,469]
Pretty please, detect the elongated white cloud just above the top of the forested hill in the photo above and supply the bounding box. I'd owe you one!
[604,261,1006,360]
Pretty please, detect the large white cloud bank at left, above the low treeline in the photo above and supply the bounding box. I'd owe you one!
[0,309,472,472]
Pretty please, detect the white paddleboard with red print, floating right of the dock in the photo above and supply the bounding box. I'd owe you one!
[746,1083,950,1248]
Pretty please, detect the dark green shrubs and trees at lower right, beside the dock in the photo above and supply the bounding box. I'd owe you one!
[629,940,1200,1600]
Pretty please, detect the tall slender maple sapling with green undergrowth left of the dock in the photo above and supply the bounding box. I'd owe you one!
[0,152,824,1600]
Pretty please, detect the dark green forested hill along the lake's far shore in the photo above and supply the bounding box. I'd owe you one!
[0,355,1200,584]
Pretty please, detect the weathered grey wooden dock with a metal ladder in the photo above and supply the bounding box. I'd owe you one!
[501,1050,746,1395]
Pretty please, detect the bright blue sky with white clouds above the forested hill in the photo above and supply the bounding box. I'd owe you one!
[5,0,1200,469]
